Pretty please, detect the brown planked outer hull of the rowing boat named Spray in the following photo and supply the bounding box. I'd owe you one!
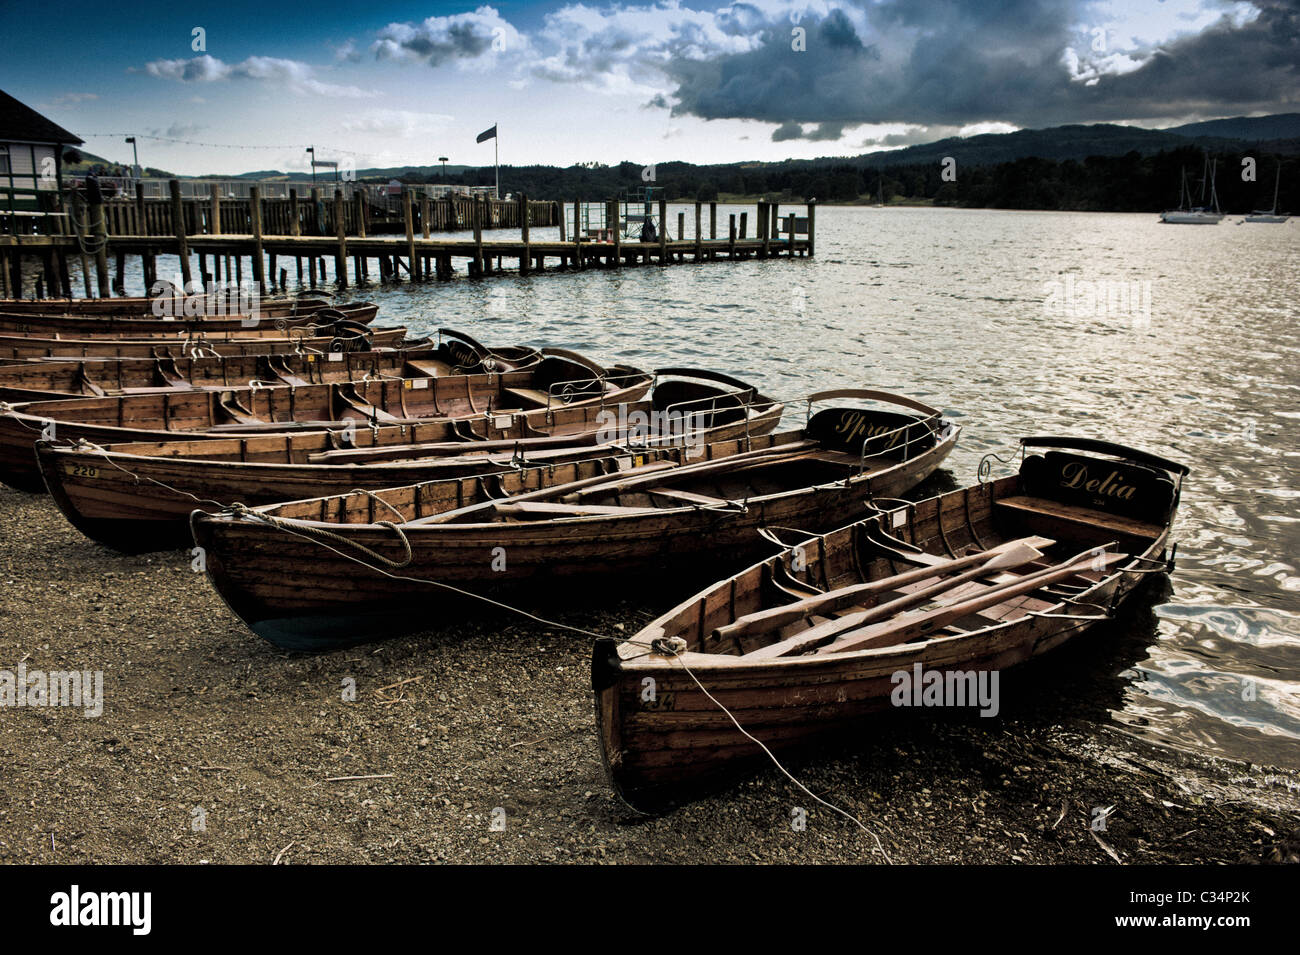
[192,427,958,650]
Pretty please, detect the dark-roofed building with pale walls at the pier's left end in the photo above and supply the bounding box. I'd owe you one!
[0,90,83,213]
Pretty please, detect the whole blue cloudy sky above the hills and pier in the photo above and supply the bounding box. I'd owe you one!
[0,0,1300,175]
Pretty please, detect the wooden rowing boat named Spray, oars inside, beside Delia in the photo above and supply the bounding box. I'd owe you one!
[192,390,959,650]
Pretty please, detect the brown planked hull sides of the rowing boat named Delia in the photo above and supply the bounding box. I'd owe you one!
[592,477,1171,812]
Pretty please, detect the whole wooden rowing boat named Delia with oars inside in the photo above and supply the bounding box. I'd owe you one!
[592,438,1187,811]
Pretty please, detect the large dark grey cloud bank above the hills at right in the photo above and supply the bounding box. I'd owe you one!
[667,0,1300,130]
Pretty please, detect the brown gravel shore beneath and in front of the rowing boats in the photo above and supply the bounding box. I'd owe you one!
[0,489,1300,864]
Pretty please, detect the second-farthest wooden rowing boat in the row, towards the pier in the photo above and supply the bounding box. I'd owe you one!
[0,301,380,340]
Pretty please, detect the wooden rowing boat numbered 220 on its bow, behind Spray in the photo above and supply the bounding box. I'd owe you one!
[36,369,783,554]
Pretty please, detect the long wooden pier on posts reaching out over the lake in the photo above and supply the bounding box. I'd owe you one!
[0,181,815,298]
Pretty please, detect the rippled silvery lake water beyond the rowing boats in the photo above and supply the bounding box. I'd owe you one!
[86,207,1300,767]
